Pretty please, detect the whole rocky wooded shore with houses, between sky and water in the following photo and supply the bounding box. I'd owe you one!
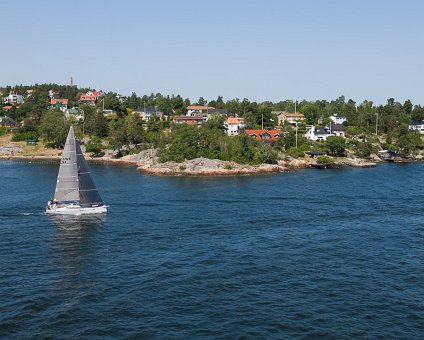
[0,84,424,176]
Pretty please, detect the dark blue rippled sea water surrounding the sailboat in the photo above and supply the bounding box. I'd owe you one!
[0,161,424,339]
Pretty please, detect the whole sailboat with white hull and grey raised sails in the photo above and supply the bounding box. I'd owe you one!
[46,126,107,215]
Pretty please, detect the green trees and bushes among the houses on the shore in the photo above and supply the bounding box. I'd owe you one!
[0,84,424,163]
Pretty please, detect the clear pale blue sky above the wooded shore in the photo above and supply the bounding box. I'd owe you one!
[0,0,424,105]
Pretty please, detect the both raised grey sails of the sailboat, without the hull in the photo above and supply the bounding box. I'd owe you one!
[54,126,103,208]
